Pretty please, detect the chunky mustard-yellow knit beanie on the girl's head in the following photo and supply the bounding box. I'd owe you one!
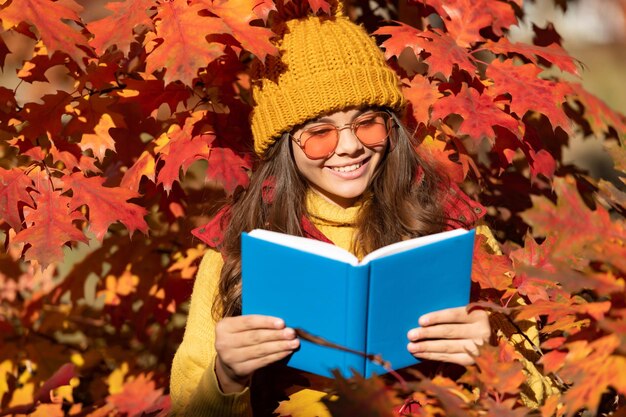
[251,16,406,155]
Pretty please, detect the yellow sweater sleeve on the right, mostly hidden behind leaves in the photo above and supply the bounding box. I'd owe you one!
[476,225,558,409]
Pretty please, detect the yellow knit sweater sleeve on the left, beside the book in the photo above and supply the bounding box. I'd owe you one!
[170,250,252,417]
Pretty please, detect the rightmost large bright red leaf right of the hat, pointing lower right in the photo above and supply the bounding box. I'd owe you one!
[487,60,572,133]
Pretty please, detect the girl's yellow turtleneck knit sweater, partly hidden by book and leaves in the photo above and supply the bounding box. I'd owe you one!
[170,193,554,417]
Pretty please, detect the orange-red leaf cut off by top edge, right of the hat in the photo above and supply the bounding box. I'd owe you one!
[420,0,517,48]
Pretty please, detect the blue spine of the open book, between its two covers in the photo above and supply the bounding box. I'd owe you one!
[342,265,370,376]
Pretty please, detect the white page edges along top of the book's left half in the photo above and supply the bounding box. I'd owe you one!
[248,229,359,265]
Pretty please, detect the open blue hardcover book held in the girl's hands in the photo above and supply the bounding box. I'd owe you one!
[241,229,474,377]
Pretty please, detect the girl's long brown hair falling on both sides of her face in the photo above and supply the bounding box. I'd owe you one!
[213,111,448,319]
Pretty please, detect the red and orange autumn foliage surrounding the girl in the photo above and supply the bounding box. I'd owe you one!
[0,0,626,416]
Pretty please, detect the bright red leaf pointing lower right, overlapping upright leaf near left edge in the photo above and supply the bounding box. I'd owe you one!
[61,172,148,241]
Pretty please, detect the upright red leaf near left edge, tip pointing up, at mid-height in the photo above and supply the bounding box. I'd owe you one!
[13,174,87,267]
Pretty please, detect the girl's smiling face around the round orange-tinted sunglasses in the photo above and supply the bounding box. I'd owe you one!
[292,109,388,208]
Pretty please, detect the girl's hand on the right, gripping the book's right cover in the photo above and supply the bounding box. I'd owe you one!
[407,307,491,366]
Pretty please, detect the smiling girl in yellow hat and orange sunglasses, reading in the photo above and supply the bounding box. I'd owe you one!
[171,6,542,417]
